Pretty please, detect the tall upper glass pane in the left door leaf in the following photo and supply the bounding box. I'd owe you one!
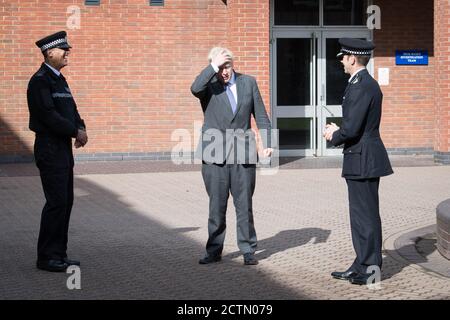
[277,38,311,106]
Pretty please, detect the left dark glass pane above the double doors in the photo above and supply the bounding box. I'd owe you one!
[275,0,320,26]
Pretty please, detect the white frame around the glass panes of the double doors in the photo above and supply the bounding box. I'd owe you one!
[269,0,374,157]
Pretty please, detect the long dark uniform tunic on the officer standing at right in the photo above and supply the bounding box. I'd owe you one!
[331,69,393,179]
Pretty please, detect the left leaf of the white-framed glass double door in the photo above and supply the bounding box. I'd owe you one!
[272,31,318,156]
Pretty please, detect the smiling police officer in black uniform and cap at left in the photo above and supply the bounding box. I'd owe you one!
[27,31,88,272]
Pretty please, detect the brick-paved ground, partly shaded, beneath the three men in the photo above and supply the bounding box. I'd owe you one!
[0,160,450,300]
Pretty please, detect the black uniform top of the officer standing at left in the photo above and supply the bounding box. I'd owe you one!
[27,63,85,168]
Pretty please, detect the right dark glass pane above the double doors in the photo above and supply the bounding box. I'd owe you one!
[323,0,368,26]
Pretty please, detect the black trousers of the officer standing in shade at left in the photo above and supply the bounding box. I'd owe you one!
[35,139,74,260]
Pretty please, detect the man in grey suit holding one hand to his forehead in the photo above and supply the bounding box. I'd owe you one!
[191,47,272,265]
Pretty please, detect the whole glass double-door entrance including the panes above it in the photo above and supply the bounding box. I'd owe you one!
[270,0,372,156]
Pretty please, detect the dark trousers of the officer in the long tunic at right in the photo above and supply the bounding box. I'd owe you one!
[346,178,383,273]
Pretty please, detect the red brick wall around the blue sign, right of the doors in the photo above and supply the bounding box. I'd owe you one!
[374,0,436,148]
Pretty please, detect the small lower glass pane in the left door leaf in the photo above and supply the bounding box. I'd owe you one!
[277,118,311,150]
